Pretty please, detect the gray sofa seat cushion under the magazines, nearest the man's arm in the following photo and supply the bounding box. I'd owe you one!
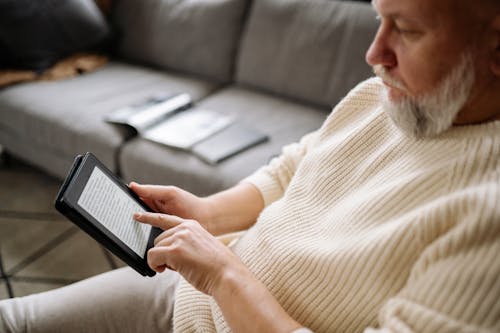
[119,86,328,195]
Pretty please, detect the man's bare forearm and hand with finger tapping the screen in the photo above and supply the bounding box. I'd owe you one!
[134,206,300,333]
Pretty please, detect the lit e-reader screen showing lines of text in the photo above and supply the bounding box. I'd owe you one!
[78,167,151,258]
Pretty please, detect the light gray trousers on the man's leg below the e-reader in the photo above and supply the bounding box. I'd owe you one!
[0,267,179,333]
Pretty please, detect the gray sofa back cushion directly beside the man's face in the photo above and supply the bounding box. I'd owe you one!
[236,0,377,106]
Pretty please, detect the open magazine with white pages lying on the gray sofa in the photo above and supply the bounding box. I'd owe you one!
[105,93,233,150]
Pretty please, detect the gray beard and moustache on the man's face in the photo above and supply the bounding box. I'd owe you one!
[374,53,474,139]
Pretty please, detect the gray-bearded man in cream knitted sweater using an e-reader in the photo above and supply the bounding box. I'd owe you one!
[0,0,500,332]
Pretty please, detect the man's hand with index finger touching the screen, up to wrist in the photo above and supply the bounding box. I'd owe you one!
[134,213,246,295]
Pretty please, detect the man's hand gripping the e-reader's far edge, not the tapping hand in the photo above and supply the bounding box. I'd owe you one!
[129,182,214,232]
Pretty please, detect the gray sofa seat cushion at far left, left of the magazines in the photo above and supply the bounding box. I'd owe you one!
[0,62,216,177]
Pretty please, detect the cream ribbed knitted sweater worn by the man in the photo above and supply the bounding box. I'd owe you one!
[174,79,500,332]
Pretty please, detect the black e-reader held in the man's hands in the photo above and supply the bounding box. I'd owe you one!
[55,153,162,276]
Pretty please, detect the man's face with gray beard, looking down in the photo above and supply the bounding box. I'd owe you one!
[366,0,475,138]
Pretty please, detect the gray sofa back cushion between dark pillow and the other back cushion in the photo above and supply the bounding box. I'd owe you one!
[113,0,247,82]
